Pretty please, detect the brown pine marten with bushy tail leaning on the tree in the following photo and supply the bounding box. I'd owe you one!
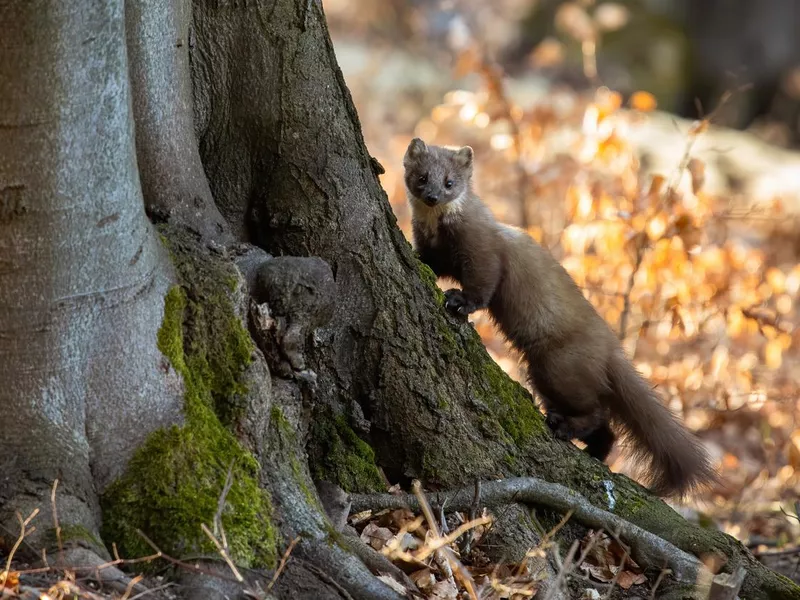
[403,138,715,496]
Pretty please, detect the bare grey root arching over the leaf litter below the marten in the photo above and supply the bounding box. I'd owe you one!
[351,477,711,585]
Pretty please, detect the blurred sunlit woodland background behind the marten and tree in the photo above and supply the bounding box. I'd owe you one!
[323,0,800,579]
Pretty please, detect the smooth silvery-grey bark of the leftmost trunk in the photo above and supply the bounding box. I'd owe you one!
[0,0,181,542]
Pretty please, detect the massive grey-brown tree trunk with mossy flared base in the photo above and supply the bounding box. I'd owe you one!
[0,0,800,598]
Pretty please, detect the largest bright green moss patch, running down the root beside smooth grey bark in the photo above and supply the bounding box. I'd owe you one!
[102,232,276,566]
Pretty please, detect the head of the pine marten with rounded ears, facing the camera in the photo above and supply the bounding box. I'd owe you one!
[403,138,472,207]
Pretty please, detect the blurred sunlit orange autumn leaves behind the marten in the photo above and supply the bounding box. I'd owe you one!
[372,65,800,544]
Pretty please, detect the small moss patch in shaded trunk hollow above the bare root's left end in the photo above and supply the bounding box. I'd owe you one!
[314,414,385,492]
